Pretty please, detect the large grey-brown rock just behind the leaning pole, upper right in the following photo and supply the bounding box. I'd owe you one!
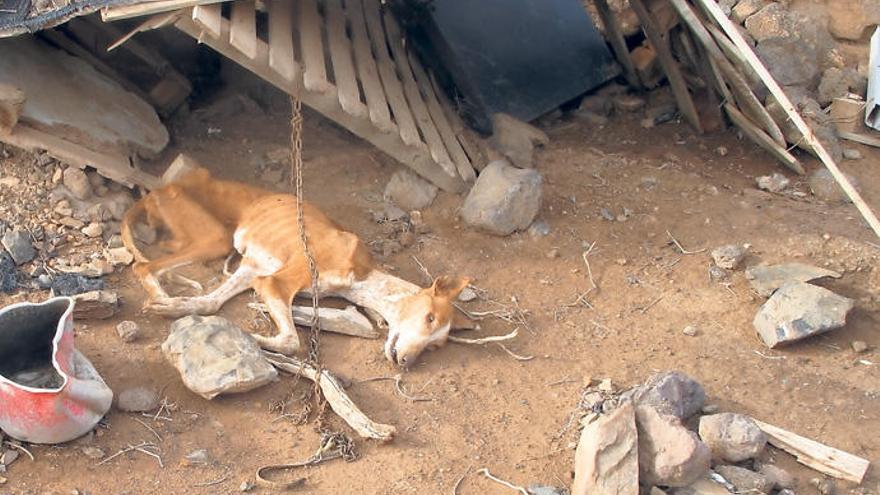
[752,36,819,87]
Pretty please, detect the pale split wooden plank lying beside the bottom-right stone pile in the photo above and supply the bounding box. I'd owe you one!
[755,420,871,484]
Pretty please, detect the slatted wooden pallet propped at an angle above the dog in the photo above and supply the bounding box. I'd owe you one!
[175,0,476,192]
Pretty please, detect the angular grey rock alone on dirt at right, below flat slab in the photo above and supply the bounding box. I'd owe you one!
[753,282,853,349]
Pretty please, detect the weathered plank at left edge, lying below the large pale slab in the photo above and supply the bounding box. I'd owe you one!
[0,123,161,189]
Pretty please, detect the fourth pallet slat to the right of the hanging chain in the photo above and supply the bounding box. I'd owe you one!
[363,0,425,146]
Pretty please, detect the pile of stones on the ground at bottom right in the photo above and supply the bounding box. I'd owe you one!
[571,371,844,495]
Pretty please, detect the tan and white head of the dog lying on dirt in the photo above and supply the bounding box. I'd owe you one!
[385,276,470,367]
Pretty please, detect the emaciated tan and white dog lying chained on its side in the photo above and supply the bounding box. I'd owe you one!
[121,168,469,366]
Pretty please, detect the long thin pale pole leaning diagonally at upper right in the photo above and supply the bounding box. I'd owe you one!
[694,0,880,237]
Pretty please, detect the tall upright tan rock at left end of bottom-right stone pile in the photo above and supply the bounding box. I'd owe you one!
[571,402,639,495]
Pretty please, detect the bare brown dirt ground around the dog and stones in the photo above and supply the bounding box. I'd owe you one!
[0,75,880,495]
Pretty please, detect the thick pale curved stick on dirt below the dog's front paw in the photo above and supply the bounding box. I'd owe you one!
[263,351,397,442]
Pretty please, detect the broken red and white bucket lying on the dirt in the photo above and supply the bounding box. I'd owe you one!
[0,297,113,444]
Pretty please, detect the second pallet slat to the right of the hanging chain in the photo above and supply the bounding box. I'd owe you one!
[324,0,367,117]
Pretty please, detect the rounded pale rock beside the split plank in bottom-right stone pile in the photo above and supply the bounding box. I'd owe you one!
[700,413,767,462]
